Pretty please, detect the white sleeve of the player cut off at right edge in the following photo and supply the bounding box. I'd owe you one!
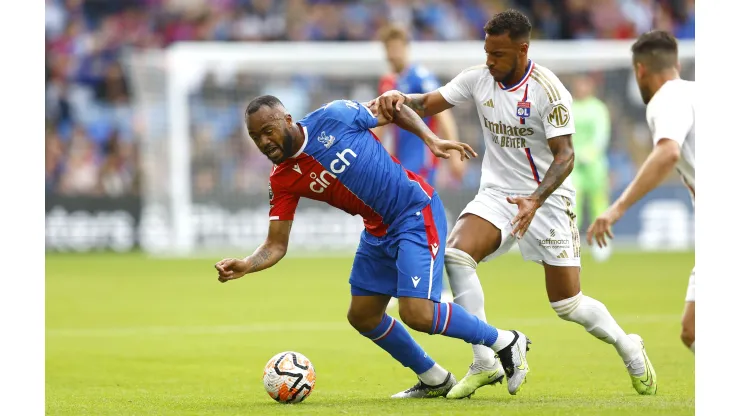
[646,85,694,146]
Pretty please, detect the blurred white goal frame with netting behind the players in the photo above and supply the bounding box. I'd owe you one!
[127,41,694,256]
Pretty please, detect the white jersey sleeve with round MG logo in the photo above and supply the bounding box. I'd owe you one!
[532,66,576,140]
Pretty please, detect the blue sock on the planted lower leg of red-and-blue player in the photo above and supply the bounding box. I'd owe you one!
[362,314,434,374]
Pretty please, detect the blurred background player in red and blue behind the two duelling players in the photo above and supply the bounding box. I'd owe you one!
[376,25,465,307]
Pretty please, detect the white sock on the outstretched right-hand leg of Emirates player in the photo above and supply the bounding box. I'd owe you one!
[550,292,645,375]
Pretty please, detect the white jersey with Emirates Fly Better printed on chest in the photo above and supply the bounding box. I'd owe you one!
[438,60,576,198]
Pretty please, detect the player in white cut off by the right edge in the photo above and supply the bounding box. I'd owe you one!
[586,30,696,352]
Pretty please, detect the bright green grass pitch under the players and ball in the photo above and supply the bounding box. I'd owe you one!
[46,249,694,416]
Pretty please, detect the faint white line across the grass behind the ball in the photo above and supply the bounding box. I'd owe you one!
[46,312,681,338]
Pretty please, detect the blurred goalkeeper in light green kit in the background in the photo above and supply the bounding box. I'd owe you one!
[571,75,611,261]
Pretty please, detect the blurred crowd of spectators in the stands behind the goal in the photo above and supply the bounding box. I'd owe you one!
[45,0,694,196]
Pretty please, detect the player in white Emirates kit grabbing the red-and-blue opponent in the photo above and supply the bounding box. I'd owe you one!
[376,10,657,398]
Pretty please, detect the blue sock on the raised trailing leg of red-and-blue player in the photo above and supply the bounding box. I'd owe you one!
[429,303,498,347]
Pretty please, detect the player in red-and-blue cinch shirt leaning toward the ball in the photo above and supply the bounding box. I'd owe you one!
[216,95,526,398]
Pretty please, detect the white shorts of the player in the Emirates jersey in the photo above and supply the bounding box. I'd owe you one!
[458,188,581,267]
